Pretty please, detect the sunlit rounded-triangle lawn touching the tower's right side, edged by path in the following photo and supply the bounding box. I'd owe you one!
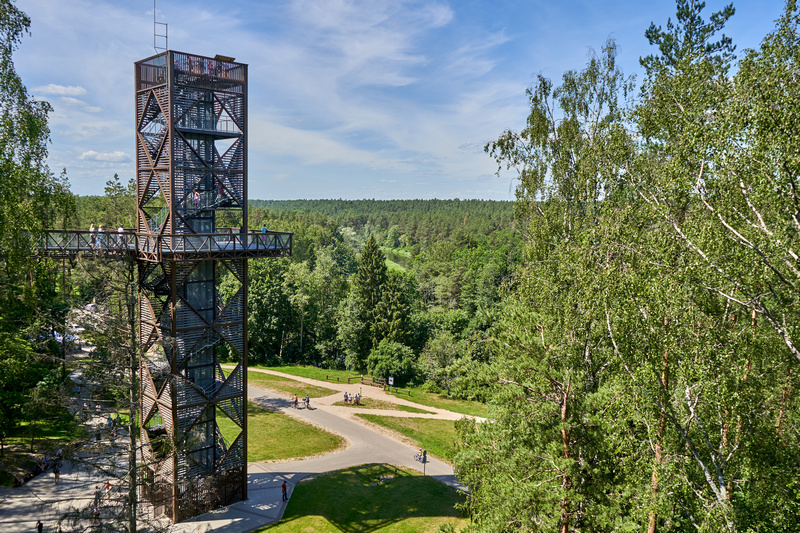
[217,402,344,462]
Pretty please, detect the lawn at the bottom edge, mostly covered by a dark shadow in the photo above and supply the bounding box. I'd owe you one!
[260,465,468,533]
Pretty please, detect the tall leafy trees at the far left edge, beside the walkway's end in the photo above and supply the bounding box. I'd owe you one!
[0,0,74,454]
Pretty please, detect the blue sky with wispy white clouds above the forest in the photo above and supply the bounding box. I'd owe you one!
[14,0,784,200]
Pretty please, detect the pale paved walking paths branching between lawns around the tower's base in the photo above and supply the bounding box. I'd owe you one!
[0,369,476,533]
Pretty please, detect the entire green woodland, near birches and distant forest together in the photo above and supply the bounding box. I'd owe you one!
[0,0,800,533]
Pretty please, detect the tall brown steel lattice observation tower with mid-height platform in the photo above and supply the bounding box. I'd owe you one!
[133,51,291,522]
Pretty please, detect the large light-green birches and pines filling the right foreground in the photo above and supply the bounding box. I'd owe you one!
[460,1,800,531]
